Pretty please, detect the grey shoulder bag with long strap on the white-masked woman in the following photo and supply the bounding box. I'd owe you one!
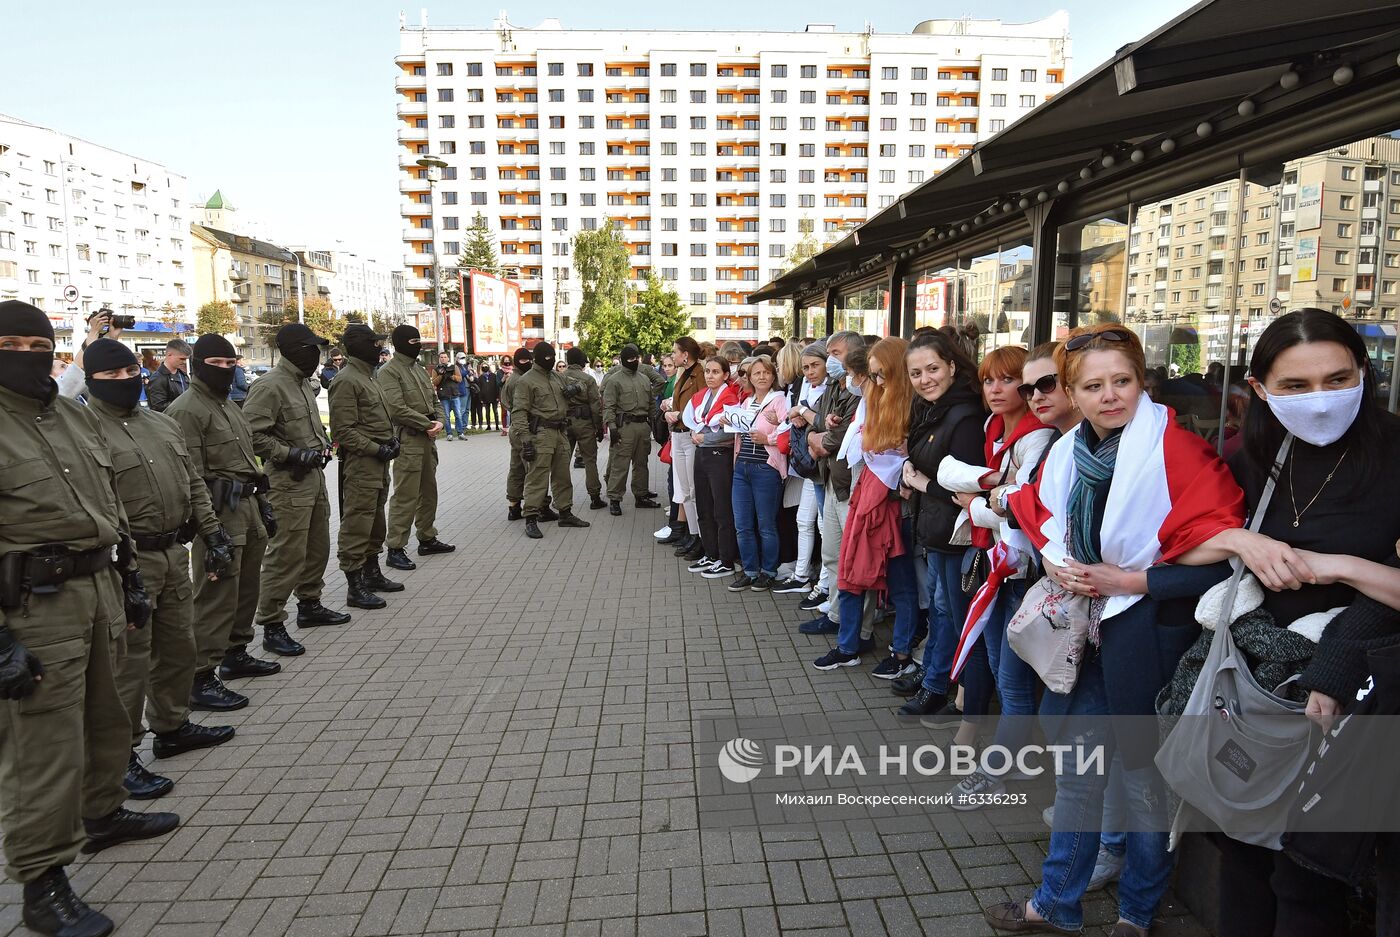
[1156,434,1316,849]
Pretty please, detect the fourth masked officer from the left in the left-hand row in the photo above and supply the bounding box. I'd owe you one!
[244,322,350,657]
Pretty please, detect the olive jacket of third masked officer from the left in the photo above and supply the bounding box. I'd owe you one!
[165,377,267,546]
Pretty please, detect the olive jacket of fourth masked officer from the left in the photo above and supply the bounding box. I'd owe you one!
[244,357,330,492]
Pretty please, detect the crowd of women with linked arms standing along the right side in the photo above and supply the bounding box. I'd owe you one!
[657,310,1400,937]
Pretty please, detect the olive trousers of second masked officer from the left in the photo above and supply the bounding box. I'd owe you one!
[116,543,195,748]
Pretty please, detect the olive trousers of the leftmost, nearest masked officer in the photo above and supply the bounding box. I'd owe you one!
[0,570,132,882]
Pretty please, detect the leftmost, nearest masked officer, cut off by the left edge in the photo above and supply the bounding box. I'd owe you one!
[0,300,179,934]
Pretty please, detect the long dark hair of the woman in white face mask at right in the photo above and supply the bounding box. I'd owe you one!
[1243,307,1393,480]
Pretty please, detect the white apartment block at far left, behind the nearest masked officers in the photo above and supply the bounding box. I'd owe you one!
[0,115,193,352]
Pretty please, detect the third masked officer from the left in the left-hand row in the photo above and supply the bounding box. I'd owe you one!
[165,335,281,712]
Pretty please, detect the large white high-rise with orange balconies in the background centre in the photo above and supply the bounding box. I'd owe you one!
[395,13,1070,342]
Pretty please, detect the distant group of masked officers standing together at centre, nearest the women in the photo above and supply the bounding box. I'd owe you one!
[501,342,666,539]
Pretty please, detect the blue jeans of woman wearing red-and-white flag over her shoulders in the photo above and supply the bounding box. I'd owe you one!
[1030,654,1172,930]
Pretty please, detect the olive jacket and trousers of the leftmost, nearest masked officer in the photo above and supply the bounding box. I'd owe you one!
[0,388,132,882]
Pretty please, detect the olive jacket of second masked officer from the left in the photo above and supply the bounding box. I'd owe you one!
[88,398,218,536]
